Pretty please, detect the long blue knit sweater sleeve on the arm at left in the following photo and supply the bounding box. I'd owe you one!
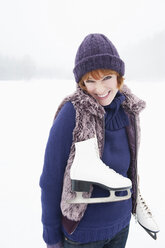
[39,102,76,245]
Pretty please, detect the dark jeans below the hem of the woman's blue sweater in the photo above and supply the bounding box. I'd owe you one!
[64,225,129,248]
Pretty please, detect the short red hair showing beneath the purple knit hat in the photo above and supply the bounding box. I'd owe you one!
[78,69,124,91]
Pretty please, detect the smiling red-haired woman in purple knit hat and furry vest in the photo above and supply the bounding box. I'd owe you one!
[40,34,158,248]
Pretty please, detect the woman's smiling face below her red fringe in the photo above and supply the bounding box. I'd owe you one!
[84,74,118,106]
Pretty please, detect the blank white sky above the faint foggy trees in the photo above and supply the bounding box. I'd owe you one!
[0,0,165,79]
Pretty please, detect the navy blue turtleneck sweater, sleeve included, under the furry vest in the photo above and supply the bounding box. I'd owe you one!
[40,91,132,244]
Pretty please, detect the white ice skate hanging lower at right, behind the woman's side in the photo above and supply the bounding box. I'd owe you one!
[136,191,159,239]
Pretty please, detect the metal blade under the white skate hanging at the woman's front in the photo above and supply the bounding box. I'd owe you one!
[67,189,131,204]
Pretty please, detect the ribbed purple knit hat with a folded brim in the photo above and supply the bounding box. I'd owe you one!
[73,33,125,83]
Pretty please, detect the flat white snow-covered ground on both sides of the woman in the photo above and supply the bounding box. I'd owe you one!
[0,80,165,248]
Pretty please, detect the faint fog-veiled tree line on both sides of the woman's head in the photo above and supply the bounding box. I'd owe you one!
[0,30,165,81]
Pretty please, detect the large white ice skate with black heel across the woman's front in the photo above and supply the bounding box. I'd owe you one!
[69,137,132,203]
